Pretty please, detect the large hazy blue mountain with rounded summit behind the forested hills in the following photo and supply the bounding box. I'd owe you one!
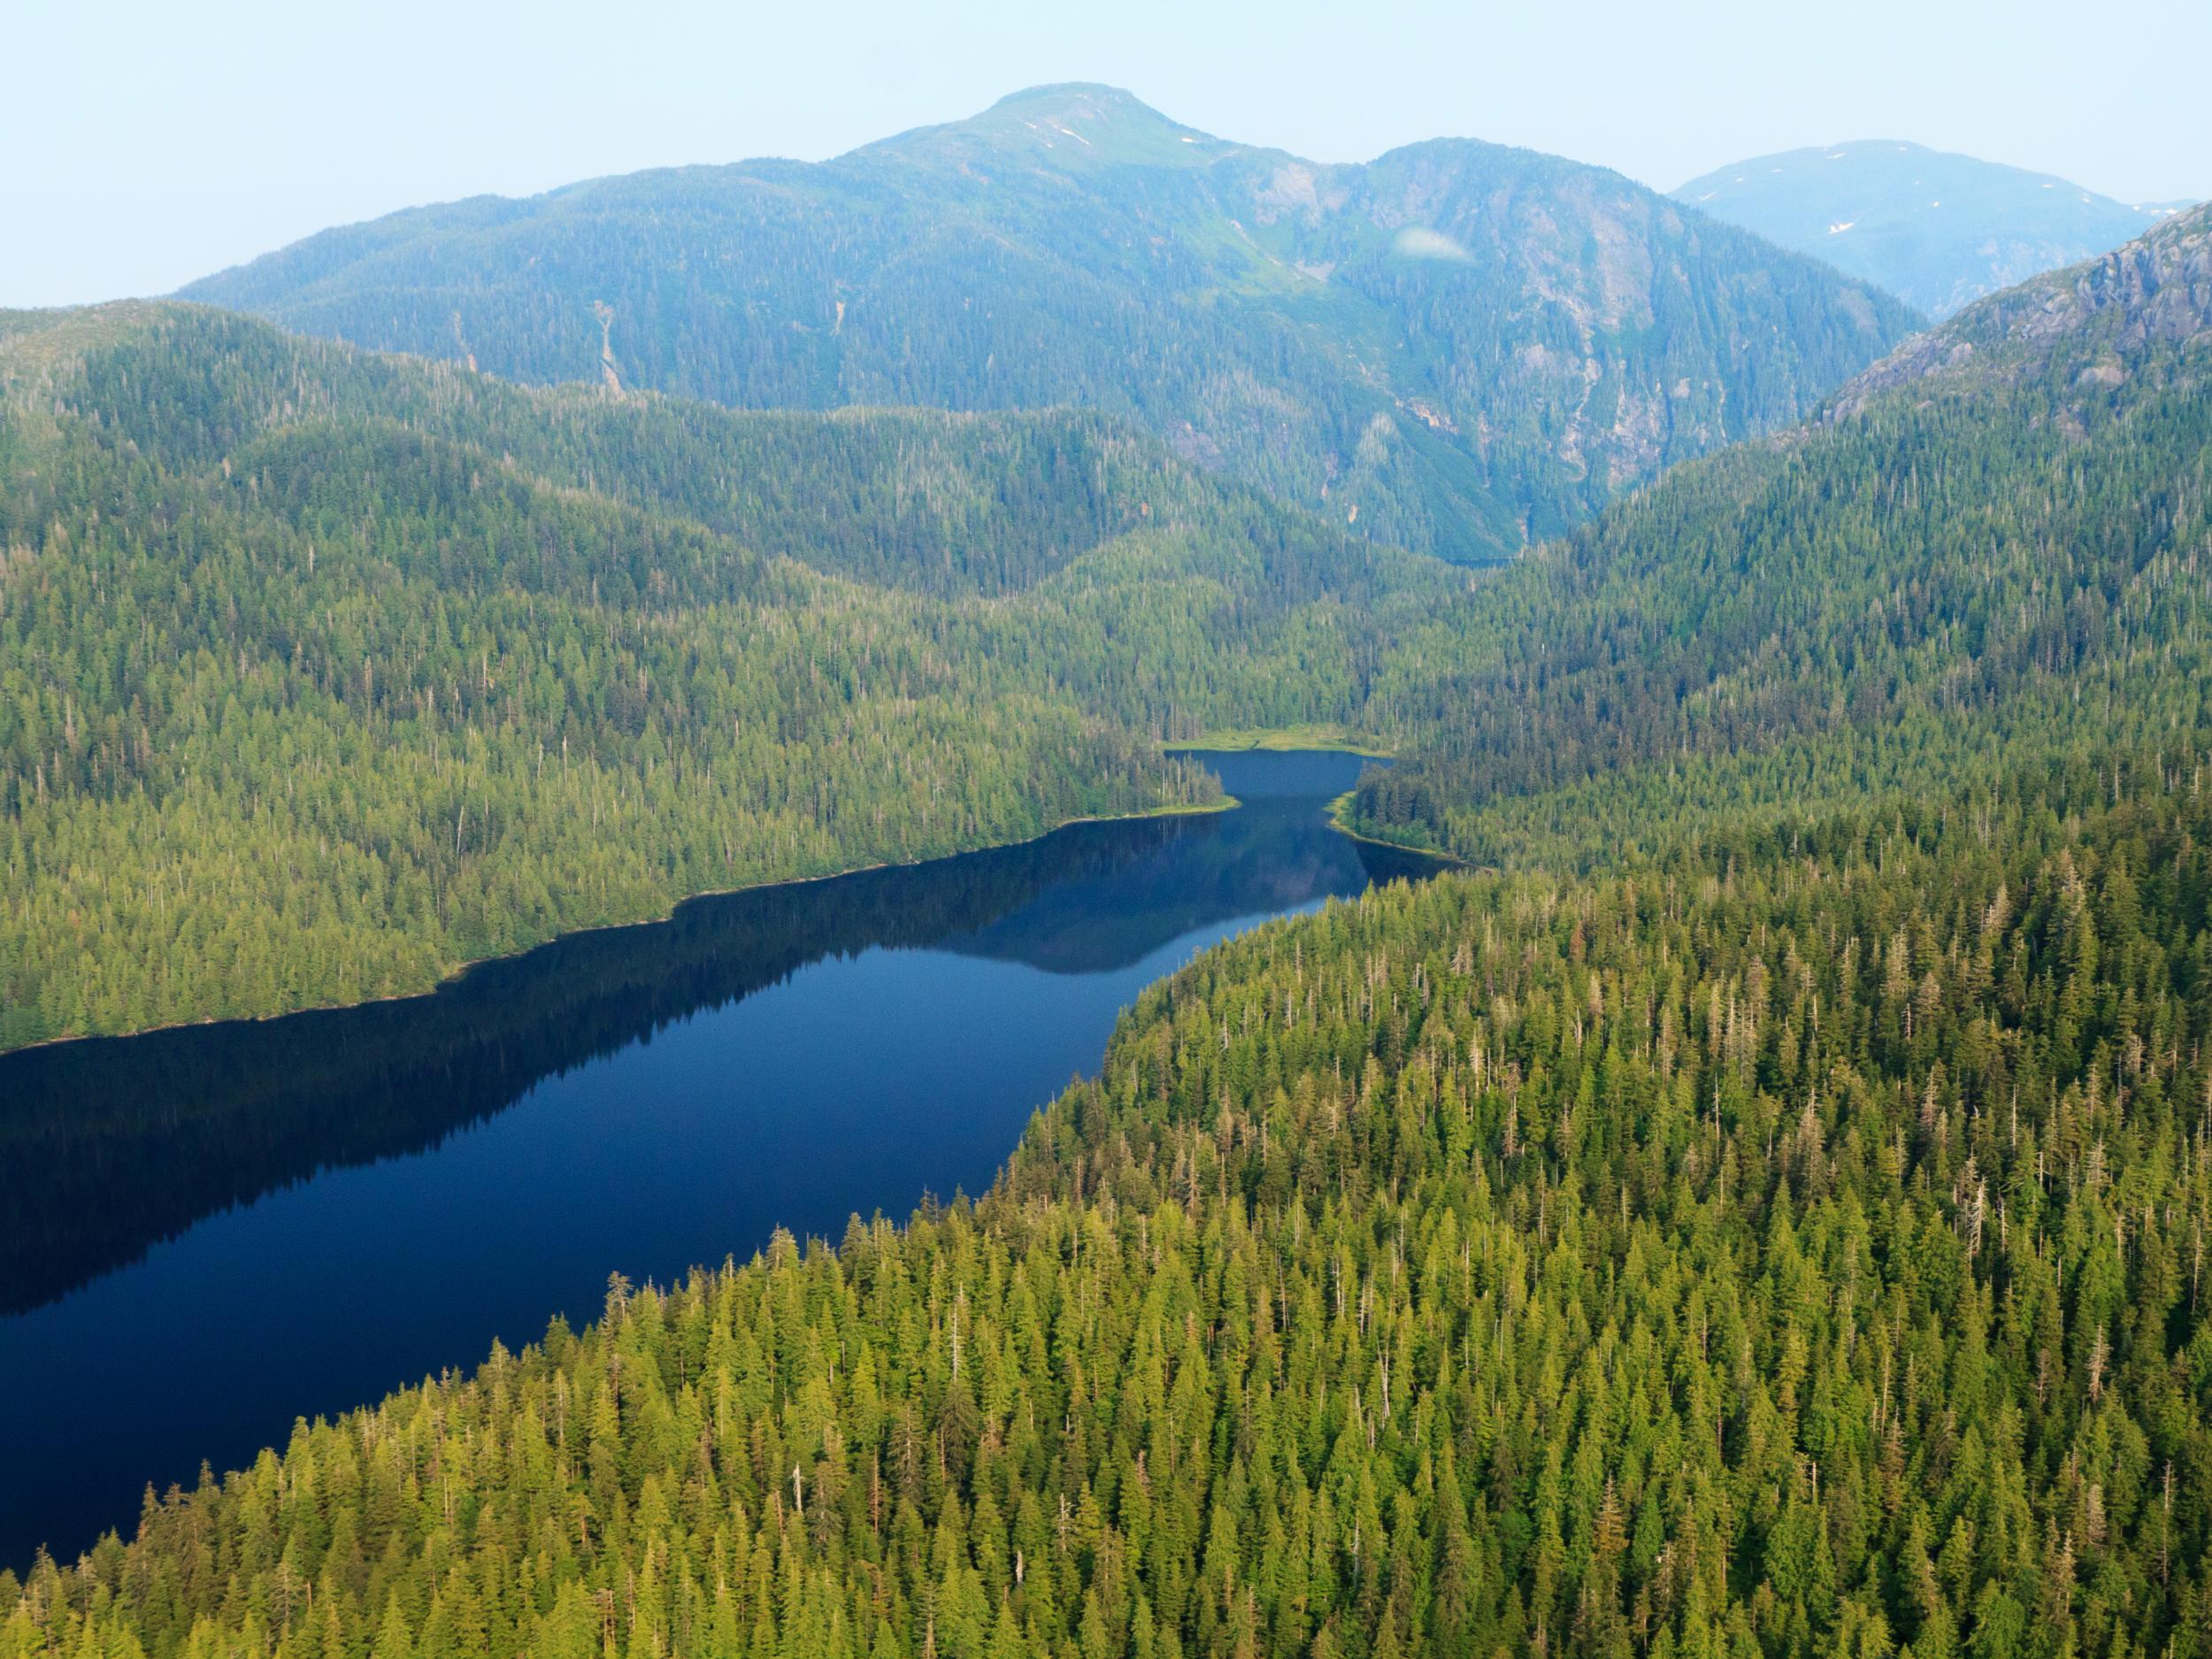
[184,87,1914,562]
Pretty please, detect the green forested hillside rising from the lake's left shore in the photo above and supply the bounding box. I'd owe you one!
[0,308,1442,1047]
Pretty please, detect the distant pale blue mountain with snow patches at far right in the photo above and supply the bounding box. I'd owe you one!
[1672,140,2193,319]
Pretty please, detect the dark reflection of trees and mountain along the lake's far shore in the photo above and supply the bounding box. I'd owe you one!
[0,801,1442,1314]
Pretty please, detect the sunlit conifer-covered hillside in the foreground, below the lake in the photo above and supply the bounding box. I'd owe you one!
[0,748,2212,1659]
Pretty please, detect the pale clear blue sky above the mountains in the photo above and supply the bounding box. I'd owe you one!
[0,0,2212,305]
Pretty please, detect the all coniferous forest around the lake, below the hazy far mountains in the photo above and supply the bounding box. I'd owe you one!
[0,74,2212,1659]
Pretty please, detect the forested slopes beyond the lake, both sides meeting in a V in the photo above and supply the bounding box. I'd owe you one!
[0,197,2212,1042]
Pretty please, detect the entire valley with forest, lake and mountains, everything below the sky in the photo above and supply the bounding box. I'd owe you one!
[0,66,2212,1659]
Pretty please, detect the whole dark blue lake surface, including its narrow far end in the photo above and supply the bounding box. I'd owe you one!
[0,755,1433,1571]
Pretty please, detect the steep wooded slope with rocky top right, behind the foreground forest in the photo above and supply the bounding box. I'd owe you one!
[1356,206,2212,867]
